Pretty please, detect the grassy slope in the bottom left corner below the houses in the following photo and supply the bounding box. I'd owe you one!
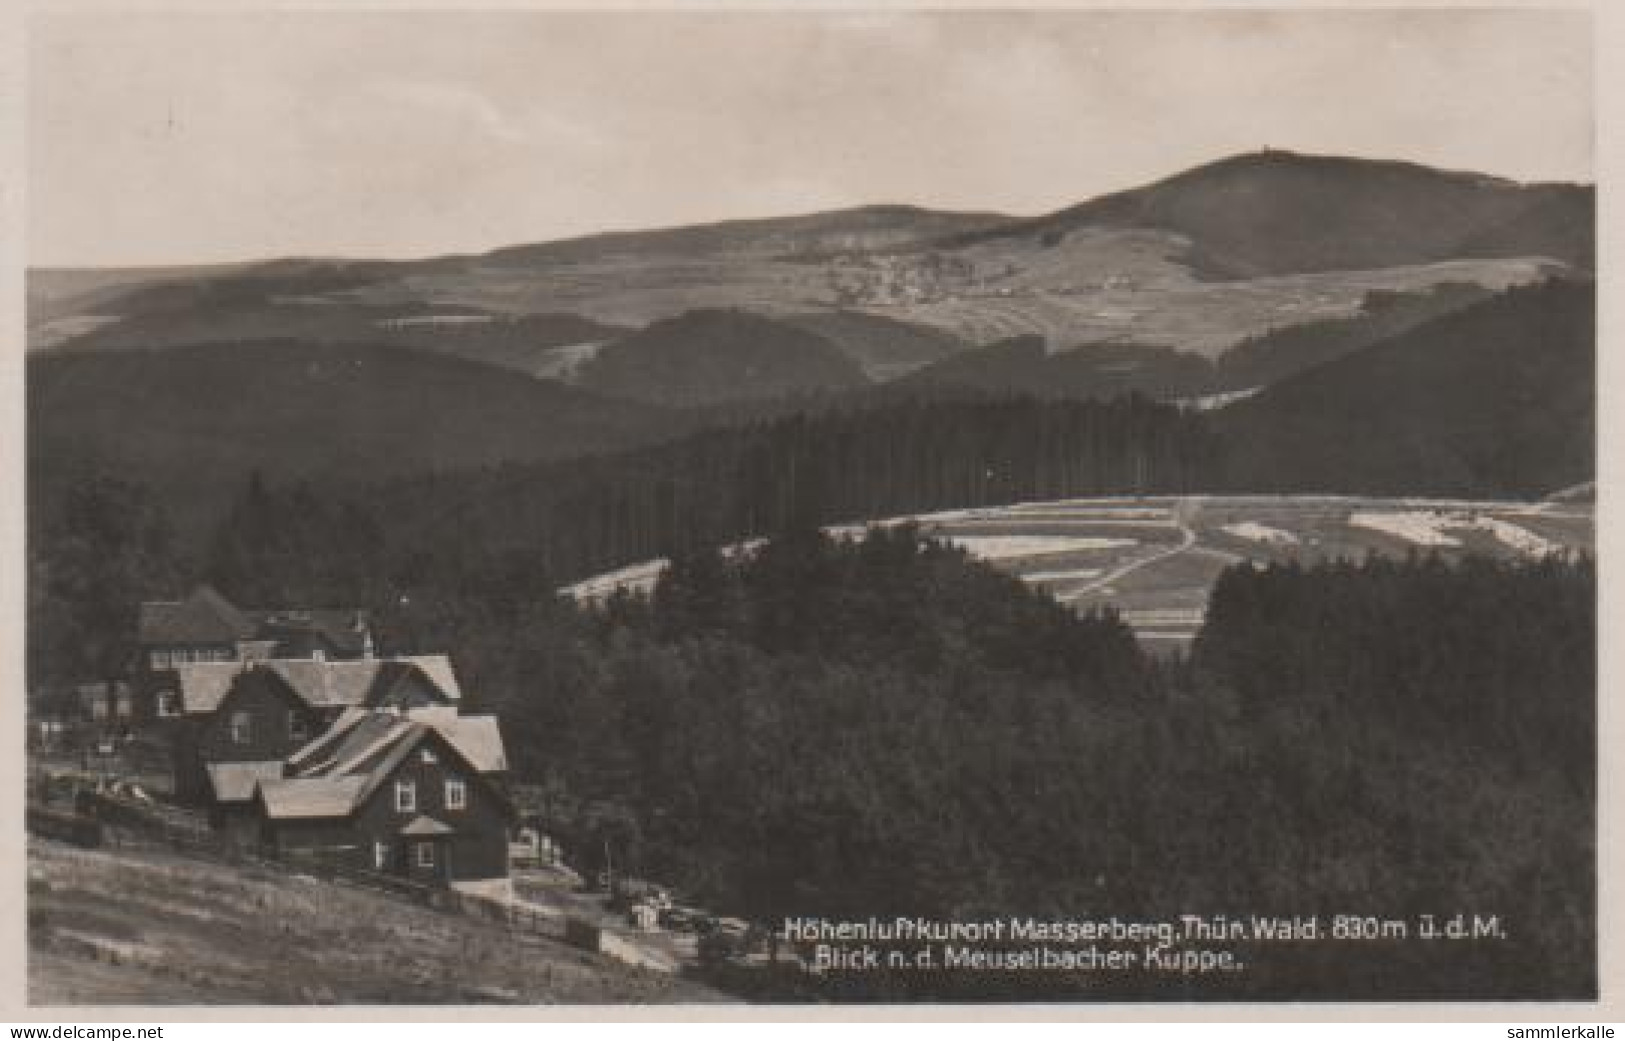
[28,840,720,1005]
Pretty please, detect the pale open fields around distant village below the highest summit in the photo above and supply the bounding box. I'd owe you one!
[354,229,1558,354]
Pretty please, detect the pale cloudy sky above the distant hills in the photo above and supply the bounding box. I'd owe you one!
[26,10,1594,266]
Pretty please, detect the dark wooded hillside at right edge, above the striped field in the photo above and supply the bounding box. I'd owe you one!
[1212,281,1596,497]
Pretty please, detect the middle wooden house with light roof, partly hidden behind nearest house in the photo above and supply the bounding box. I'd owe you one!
[170,654,463,805]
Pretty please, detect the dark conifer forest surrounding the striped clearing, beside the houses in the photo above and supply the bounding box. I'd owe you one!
[28,276,1596,999]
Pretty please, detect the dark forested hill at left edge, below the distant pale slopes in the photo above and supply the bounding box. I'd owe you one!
[28,341,681,536]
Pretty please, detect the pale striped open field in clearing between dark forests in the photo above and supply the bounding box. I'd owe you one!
[566,495,1594,650]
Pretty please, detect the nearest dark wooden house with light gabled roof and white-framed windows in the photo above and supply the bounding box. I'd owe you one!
[254,708,515,888]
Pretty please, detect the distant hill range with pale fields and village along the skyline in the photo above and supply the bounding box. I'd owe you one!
[29,151,1594,360]
